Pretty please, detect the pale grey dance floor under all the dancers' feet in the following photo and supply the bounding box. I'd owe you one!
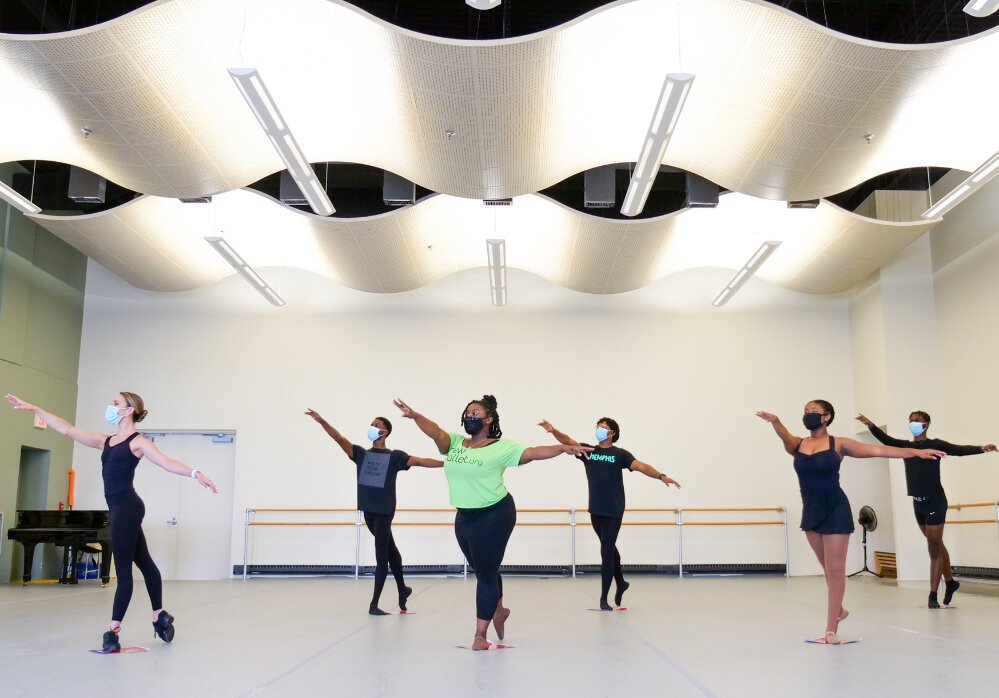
[0,575,999,698]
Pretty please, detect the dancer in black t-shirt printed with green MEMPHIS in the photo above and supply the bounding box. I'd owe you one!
[538,417,680,611]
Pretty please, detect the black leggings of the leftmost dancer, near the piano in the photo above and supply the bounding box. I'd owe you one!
[108,495,163,623]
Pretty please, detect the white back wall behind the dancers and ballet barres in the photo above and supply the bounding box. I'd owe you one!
[70,264,883,574]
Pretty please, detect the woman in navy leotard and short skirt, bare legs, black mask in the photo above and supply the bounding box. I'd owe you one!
[756,400,946,645]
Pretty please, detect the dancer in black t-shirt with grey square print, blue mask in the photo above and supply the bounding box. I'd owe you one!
[305,408,444,616]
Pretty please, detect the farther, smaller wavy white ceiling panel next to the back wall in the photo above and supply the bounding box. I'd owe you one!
[32,190,937,300]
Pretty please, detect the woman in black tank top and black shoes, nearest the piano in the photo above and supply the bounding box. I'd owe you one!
[4,392,218,652]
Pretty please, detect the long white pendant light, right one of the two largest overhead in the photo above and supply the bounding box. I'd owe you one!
[621,73,694,216]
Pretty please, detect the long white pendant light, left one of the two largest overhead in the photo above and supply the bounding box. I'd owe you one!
[229,68,336,216]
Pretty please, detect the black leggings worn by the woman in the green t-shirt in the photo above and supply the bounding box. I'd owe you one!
[454,494,517,620]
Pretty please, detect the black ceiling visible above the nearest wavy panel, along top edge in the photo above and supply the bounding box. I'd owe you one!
[0,0,999,44]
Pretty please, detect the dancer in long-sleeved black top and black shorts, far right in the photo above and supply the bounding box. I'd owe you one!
[857,410,996,608]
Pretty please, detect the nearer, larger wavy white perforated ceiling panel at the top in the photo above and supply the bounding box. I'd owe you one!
[0,0,999,200]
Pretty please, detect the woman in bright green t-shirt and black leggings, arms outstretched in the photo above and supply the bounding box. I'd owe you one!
[393,395,593,650]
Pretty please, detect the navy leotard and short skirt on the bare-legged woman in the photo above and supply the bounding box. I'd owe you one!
[794,434,854,535]
